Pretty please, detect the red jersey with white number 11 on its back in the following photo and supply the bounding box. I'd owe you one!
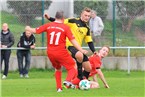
[36,22,74,50]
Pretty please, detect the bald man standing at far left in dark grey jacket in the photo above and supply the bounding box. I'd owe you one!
[0,23,14,79]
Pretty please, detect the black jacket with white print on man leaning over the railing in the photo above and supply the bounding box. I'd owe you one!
[17,32,35,48]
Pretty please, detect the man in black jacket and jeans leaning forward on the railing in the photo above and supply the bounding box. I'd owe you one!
[17,31,35,78]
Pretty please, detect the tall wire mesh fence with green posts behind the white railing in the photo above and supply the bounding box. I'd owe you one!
[0,0,145,56]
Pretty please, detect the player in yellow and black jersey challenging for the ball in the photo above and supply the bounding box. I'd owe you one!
[45,8,95,84]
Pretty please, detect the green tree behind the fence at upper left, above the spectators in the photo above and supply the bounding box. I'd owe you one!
[7,0,51,24]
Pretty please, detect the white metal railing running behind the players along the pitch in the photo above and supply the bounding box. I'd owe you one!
[0,47,145,74]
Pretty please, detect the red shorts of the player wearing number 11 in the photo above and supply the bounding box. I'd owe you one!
[47,49,75,70]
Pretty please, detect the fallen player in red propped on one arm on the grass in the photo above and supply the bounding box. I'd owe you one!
[72,46,110,88]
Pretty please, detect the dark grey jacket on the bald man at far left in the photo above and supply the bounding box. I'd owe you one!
[0,29,15,48]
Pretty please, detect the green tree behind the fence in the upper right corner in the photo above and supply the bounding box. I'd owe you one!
[116,1,145,32]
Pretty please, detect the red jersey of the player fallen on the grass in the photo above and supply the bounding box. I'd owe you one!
[89,54,102,76]
